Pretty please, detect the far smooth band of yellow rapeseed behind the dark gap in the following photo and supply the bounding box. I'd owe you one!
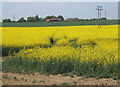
[2,25,118,46]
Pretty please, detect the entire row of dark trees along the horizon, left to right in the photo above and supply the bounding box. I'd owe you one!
[2,15,106,22]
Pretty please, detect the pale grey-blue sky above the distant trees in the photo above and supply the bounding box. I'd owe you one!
[0,2,118,20]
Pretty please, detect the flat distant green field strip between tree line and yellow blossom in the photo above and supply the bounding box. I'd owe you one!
[2,20,118,27]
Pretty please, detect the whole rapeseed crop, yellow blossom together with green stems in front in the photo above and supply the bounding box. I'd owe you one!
[2,25,120,77]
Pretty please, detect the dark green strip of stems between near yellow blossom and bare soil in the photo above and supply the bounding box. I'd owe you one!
[3,57,120,79]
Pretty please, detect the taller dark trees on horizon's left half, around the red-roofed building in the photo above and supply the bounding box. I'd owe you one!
[2,15,64,22]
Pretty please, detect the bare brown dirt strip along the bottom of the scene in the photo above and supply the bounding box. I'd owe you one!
[3,73,120,85]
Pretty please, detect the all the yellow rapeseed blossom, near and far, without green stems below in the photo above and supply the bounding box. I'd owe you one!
[2,25,118,63]
